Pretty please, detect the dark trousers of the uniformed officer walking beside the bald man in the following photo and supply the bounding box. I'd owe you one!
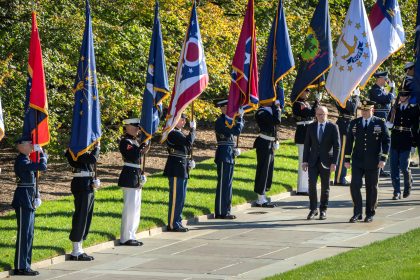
[350,165,379,216]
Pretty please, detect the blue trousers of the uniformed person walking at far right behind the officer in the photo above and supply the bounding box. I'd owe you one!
[390,149,411,195]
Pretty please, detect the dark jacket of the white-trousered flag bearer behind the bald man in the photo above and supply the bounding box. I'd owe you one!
[292,98,318,144]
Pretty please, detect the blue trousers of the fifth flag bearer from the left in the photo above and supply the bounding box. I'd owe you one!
[214,162,234,216]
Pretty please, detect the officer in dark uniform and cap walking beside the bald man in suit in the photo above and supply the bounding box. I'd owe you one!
[345,100,391,223]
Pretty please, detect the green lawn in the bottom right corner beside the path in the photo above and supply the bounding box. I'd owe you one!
[266,229,420,280]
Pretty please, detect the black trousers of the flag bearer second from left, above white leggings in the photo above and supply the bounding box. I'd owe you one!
[70,190,95,242]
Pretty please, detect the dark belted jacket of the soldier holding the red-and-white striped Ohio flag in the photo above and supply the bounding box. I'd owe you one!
[163,128,195,178]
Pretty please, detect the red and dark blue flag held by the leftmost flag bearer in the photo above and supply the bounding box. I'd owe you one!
[22,12,50,149]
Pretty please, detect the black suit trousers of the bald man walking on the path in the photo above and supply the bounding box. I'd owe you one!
[308,160,331,211]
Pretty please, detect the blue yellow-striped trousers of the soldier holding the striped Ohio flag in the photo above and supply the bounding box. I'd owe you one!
[168,177,188,229]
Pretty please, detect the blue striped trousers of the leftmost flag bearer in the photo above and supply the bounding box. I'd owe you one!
[15,207,35,270]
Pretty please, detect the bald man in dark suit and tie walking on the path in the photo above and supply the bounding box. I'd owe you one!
[302,106,340,220]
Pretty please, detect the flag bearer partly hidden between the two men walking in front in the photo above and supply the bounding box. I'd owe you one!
[334,89,360,186]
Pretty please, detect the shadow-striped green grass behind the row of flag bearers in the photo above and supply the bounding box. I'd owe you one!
[0,141,297,271]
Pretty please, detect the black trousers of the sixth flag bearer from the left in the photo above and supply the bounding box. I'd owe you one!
[254,147,274,195]
